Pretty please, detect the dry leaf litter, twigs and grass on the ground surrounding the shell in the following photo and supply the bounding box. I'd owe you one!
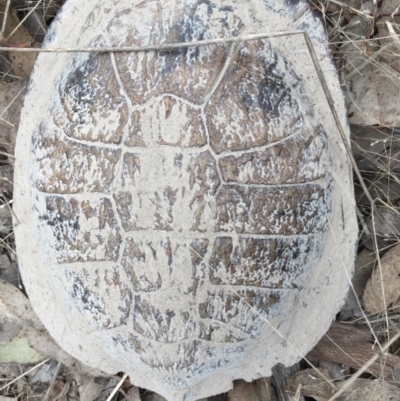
[0,0,400,401]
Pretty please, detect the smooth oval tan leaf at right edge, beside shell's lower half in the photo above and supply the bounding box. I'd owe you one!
[363,245,400,313]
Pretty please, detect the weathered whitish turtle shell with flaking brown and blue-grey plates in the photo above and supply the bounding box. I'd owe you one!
[15,0,357,401]
